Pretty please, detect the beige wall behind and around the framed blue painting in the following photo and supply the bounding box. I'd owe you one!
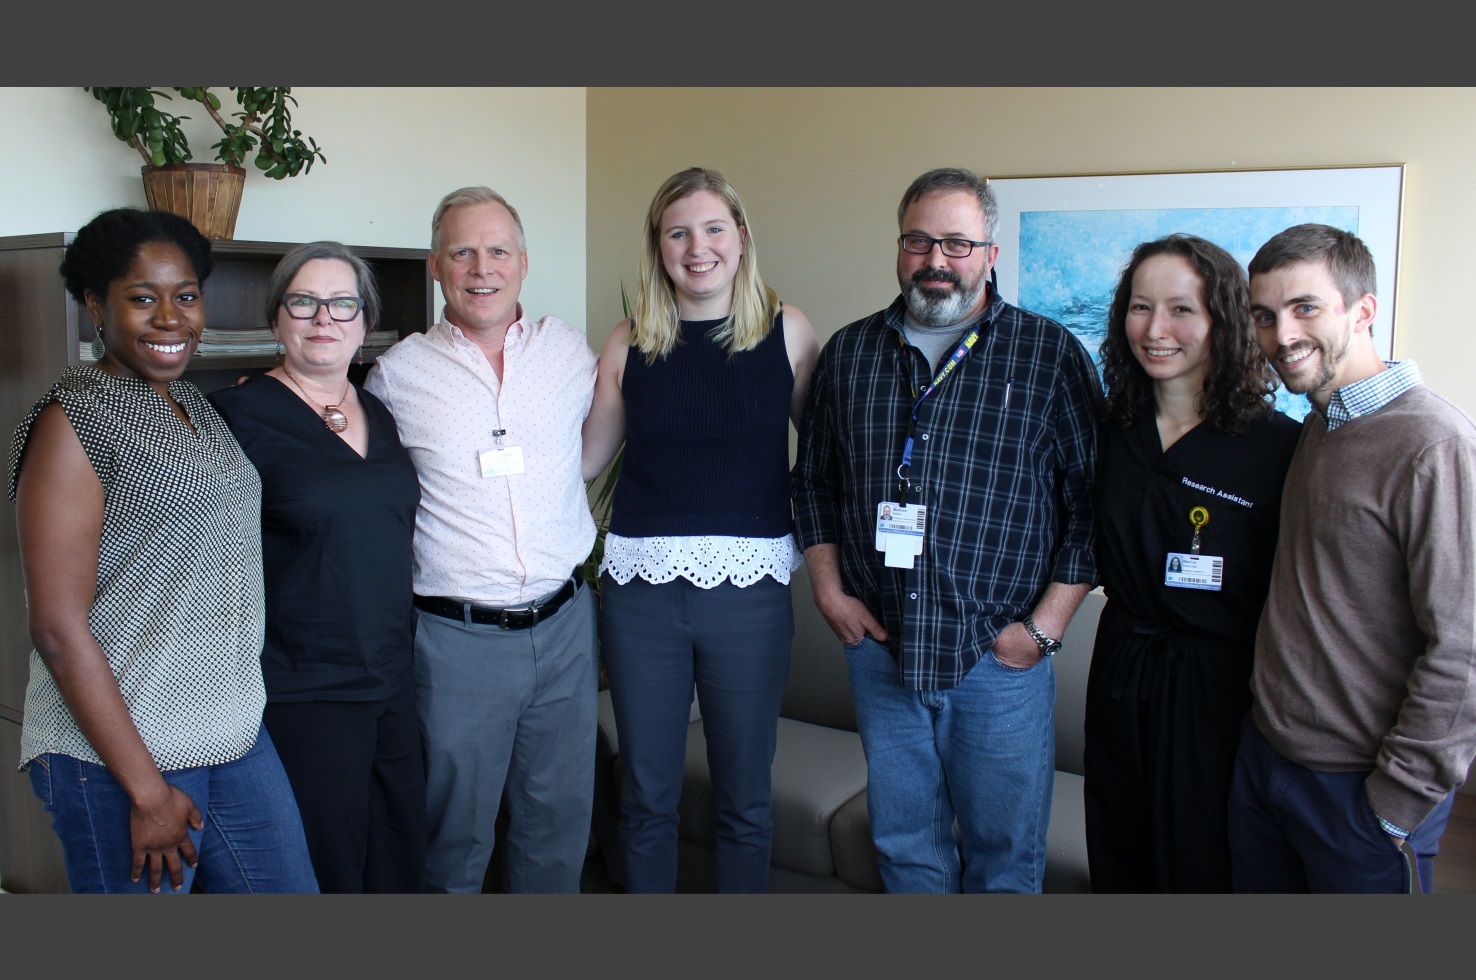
[587,89,1476,415]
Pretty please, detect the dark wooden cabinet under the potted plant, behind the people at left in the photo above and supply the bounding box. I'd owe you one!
[0,233,435,891]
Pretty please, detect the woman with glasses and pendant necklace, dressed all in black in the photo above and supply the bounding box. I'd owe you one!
[210,242,425,893]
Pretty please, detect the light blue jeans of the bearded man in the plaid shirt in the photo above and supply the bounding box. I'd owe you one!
[846,636,1055,893]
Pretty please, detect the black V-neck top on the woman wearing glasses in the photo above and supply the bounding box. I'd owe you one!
[210,375,421,701]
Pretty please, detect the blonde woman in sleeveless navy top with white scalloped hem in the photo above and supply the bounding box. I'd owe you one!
[584,167,818,891]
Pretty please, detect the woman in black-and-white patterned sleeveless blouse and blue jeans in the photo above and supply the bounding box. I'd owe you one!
[9,208,317,893]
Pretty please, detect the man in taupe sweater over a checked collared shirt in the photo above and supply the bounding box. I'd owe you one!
[1230,224,1476,891]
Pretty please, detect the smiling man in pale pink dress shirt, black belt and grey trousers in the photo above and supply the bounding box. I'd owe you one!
[366,187,598,893]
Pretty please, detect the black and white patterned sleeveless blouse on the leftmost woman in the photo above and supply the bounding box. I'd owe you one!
[9,368,266,770]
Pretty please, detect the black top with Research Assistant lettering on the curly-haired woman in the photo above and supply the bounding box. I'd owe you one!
[1095,412,1302,649]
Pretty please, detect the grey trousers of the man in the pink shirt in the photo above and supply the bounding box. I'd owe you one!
[415,586,599,893]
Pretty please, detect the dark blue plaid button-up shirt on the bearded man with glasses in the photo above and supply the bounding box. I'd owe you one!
[794,289,1101,691]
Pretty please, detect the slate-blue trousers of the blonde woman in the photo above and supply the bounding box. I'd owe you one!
[601,574,794,893]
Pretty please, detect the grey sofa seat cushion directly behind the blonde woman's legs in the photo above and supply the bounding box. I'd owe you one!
[679,717,869,875]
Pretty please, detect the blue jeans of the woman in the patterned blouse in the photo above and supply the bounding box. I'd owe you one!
[31,729,317,894]
